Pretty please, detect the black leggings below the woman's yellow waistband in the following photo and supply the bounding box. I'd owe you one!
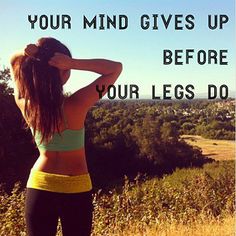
[25,188,93,236]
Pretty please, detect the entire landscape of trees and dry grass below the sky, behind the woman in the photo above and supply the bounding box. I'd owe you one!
[0,62,236,236]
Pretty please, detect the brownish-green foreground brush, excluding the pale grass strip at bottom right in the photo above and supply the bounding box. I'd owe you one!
[0,161,235,236]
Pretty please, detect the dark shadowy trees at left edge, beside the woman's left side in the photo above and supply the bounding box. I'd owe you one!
[0,69,37,190]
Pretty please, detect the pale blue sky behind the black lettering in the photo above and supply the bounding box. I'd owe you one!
[0,0,236,98]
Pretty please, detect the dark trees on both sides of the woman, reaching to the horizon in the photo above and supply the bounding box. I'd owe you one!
[0,66,234,194]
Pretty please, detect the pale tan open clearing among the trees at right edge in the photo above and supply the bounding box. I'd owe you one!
[182,135,235,161]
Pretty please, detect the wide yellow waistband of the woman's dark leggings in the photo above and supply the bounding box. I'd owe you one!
[26,169,92,193]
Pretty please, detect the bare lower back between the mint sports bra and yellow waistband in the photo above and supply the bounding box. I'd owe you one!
[32,148,88,176]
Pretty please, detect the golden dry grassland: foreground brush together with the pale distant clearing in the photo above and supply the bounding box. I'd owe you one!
[0,136,235,236]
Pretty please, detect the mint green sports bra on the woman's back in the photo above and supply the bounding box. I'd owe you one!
[31,104,85,151]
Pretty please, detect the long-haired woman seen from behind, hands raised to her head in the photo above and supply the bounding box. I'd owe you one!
[11,38,122,236]
